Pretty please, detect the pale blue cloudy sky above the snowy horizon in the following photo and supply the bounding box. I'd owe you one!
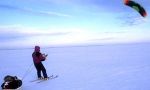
[0,0,150,48]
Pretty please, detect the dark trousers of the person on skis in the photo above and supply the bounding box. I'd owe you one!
[34,62,47,78]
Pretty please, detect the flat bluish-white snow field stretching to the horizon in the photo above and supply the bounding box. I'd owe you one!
[0,42,150,90]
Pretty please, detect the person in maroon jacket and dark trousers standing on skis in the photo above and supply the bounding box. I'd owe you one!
[32,46,48,80]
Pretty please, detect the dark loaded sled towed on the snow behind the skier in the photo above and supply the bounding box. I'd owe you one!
[1,75,22,89]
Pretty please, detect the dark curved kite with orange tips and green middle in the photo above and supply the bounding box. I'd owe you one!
[124,0,147,17]
